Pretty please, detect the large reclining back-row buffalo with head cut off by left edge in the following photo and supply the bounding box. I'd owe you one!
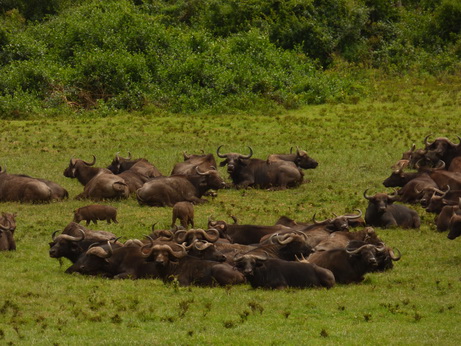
[0,167,53,203]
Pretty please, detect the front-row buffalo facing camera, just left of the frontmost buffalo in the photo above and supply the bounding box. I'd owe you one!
[146,245,245,286]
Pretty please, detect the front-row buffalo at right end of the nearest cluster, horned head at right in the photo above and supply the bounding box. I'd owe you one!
[307,241,400,284]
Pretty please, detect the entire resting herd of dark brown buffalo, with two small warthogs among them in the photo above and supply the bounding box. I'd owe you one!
[0,136,461,289]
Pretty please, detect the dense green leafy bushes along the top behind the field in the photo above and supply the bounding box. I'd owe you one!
[0,0,461,119]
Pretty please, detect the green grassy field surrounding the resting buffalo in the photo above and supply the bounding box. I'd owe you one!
[0,78,461,345]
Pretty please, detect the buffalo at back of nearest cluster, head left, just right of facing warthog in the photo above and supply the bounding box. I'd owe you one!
[208,219,292,245]
